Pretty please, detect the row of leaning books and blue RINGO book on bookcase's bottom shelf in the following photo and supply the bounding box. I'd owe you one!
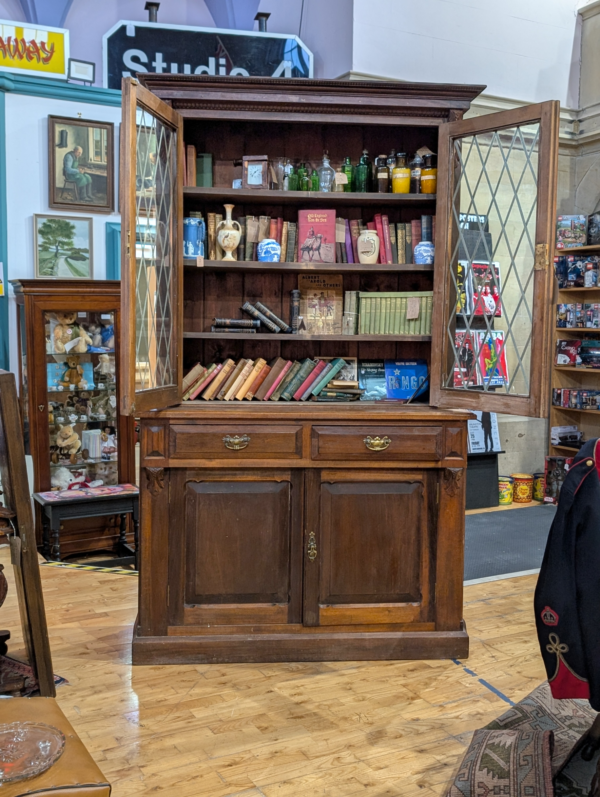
[183,357,428,402]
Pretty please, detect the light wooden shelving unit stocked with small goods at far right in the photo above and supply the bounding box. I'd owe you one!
[548,246,600,457]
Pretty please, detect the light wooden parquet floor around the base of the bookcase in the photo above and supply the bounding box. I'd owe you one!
[0,548,544,797]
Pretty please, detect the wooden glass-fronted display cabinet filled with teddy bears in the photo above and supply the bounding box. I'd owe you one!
[12,280,135,558]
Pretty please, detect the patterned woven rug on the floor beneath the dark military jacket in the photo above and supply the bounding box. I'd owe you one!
[446,683,596,797]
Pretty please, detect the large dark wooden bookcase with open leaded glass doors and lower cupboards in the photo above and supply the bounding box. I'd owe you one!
[120,74,558,664]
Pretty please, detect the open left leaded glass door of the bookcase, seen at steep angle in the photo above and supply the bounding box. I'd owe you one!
[121,78,183,415]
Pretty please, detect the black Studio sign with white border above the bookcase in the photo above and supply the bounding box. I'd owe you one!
[102,20,313,89]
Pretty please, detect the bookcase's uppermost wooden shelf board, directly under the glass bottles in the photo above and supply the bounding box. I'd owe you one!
[183,186,436,207]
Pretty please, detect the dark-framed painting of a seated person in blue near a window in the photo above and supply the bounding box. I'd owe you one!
[48,116,115,213]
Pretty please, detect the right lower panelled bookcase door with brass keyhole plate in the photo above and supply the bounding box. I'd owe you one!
[304,470,435,626]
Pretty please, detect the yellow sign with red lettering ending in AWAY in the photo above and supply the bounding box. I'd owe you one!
[0,20,69,77]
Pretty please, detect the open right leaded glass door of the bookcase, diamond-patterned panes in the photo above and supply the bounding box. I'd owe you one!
[431,102,559,416]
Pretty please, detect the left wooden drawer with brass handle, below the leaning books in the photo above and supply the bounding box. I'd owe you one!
[169,423,302,461]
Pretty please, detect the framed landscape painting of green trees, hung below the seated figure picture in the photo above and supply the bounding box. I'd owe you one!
[33,213,93,279]
